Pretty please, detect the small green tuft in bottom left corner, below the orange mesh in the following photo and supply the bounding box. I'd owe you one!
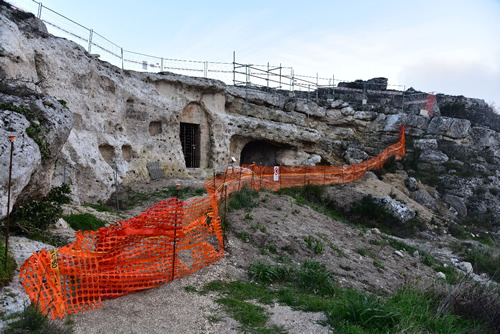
[5,304,73,334]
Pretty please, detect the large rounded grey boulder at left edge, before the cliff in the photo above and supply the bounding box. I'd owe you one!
[0,80,73,217]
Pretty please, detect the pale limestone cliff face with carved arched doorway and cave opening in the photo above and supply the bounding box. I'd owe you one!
[0,6,500,230]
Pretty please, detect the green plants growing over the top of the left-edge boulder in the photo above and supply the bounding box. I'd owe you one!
[0,102,51,160]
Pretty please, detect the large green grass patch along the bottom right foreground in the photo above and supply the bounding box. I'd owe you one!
[204,262,492,333]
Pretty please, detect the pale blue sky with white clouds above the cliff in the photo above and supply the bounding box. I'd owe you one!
[9,0,500,106]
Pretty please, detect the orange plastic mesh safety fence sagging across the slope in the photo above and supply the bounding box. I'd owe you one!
[20,126,405,319]
